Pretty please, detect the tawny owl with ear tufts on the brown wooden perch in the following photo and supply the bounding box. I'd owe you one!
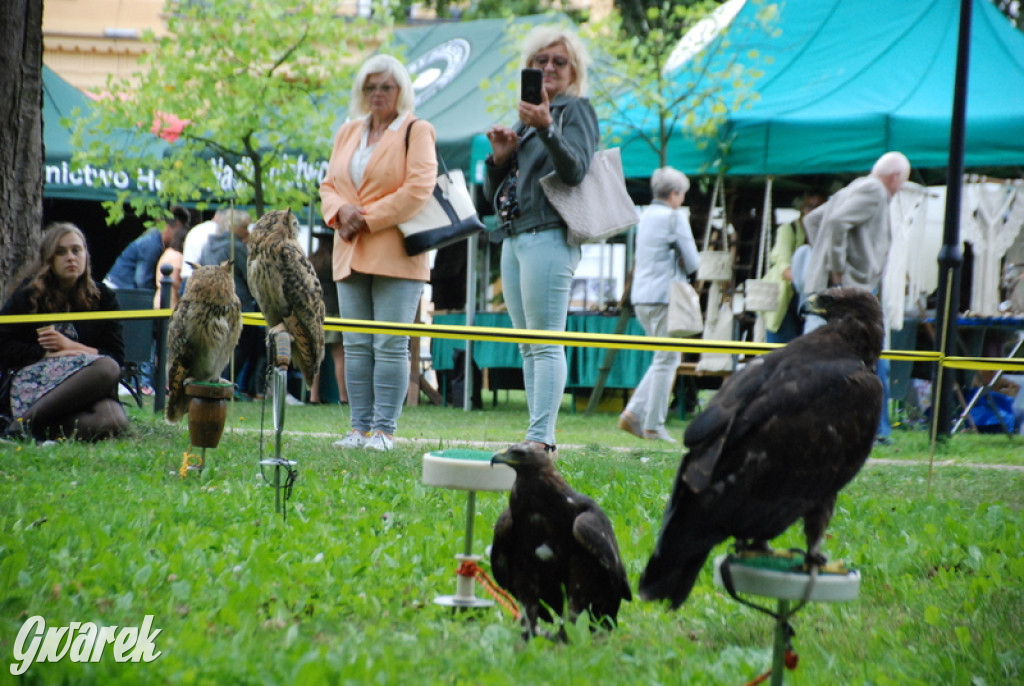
[167,262,242,422]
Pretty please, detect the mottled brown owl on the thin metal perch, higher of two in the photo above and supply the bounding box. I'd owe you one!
[248,210,327,384]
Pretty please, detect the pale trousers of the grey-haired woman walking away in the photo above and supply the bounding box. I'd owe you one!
[626,305,682,431]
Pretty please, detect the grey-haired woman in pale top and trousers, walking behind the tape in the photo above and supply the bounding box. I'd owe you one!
[618,167,700,443]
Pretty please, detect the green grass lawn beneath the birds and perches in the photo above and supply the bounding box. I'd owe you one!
[0,393,1024,686]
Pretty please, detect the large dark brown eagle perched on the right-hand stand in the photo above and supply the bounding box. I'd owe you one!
[639,288,884,609]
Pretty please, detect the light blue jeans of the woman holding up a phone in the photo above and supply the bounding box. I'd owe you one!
[502,228,581,444]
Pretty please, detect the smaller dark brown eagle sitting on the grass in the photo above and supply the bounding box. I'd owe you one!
[490,443,633,640]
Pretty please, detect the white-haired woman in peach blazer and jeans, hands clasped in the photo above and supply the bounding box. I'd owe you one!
[319,55,437,452]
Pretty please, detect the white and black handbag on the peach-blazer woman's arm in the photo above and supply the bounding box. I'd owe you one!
[398,121,485,255]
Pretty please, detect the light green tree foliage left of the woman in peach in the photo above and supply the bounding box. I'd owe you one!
[76,0,369,221]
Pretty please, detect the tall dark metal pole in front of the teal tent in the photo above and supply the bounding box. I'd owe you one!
[933,0,972,439]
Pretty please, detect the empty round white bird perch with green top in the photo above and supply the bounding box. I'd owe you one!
[423,448,515,607]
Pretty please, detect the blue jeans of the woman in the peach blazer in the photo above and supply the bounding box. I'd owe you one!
[337,271,423,435]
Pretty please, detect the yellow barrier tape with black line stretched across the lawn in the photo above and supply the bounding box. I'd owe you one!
[0,309,1024,372]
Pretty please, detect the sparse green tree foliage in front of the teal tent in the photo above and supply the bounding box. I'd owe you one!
[582,0,778,172]
